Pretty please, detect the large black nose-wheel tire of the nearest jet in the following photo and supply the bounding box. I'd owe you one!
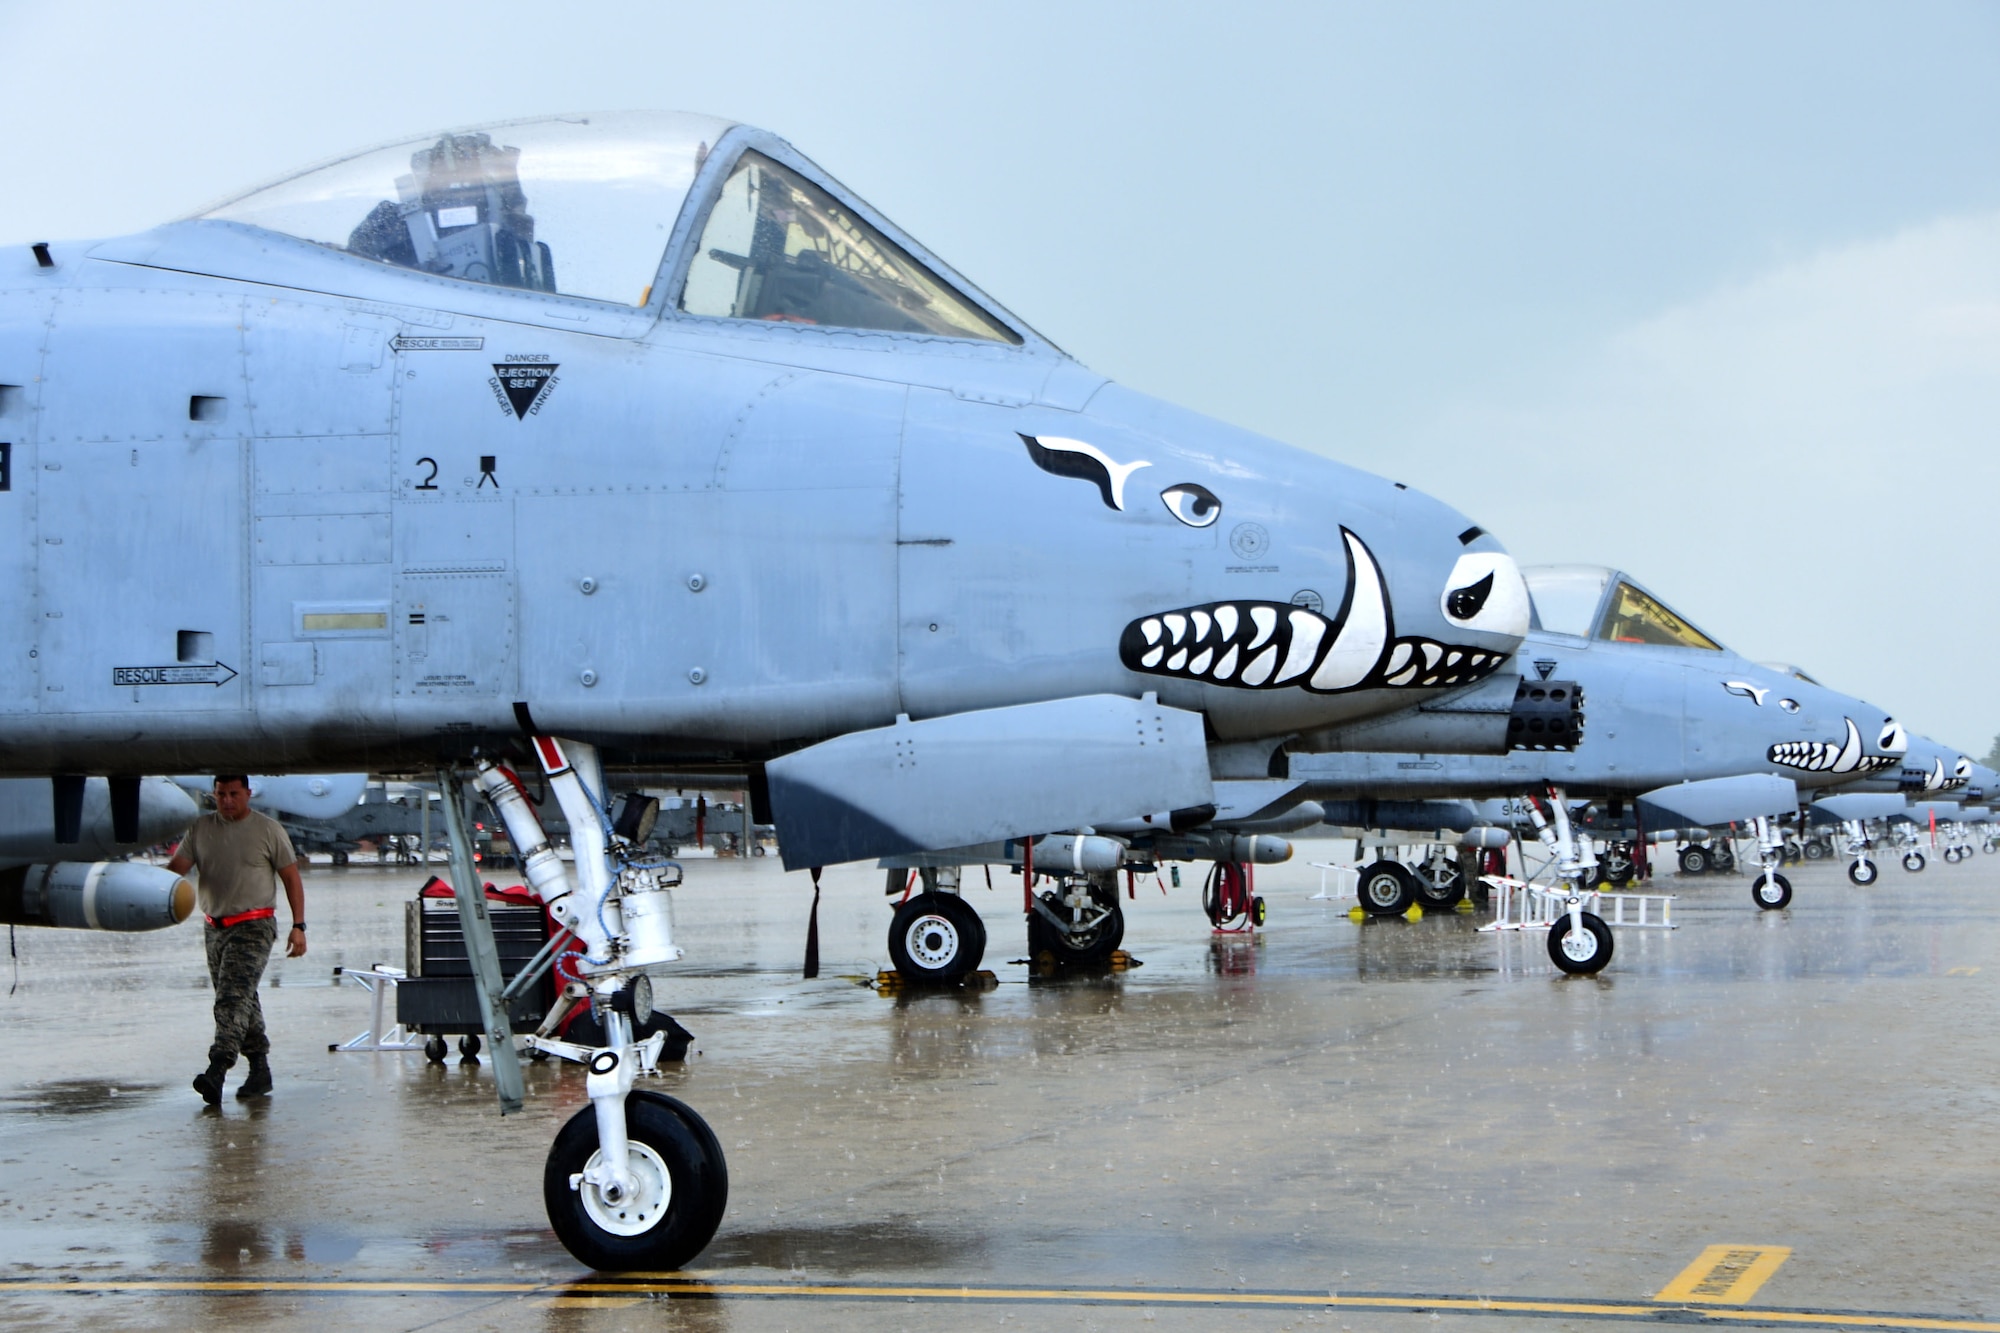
[542,1093,730,1273]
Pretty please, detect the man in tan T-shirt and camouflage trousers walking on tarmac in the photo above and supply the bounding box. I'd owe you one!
[166,773,306,1107]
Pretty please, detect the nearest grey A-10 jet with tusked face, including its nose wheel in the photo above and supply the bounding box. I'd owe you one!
[0,114,1528,1269]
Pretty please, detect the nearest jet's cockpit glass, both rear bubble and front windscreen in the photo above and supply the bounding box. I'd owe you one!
[200,112,1022,344]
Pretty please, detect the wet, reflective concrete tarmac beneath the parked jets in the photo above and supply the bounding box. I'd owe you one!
[0,845,2000,1331]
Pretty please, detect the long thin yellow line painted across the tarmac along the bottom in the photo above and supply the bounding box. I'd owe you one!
[0,1245,2000,1333]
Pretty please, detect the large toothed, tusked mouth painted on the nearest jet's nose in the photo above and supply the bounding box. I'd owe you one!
[1118,528,1506,695]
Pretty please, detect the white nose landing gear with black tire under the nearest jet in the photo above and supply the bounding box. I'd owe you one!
[458,737,730,1271]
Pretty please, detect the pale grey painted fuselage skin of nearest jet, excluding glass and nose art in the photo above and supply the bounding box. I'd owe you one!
[0,111,1526,860]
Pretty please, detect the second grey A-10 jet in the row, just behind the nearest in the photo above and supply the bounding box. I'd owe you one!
[1284,564,1910,944]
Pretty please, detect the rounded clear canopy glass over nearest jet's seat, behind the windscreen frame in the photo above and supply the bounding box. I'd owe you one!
[200,112,730,306]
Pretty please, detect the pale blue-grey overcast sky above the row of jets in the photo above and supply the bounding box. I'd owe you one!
[0,0,2000,755]
